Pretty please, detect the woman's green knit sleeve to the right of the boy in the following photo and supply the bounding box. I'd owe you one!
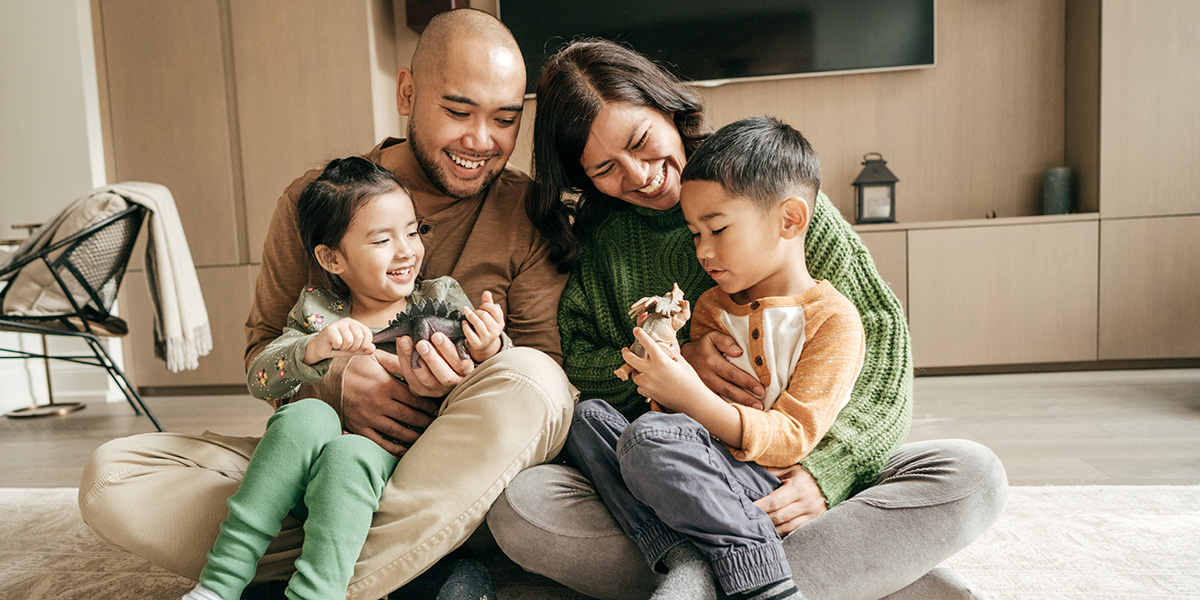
[802,194,912,508]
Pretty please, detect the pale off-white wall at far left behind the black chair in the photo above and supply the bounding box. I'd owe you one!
[0,0,113,413]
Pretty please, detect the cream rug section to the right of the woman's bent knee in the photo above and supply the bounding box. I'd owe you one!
[946,486,1200,600]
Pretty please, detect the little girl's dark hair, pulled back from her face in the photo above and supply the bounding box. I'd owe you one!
[296,156,412,294]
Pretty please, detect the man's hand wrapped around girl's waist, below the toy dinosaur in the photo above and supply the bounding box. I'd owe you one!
[342,350,439,456]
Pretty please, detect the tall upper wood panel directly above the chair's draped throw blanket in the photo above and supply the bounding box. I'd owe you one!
[98,0,239,268]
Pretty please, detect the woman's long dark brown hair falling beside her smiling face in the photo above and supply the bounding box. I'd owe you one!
[526,38,708,272]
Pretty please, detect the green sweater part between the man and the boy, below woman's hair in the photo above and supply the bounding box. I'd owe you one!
[558,205,713,420]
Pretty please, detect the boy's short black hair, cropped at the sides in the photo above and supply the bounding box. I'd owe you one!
[680,116,821,209]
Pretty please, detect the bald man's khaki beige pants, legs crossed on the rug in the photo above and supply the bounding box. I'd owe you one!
[79,348,572,599]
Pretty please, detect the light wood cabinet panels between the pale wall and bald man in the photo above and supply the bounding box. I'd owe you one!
[92,0,400,390]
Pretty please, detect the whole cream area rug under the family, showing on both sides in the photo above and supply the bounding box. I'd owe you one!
[0,486,1200,600]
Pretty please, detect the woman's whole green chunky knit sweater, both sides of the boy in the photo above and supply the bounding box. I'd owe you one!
[558,193,912,508]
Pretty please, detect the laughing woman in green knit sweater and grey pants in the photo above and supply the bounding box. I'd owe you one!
[488,40,1007,599]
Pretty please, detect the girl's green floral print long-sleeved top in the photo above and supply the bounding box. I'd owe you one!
[246,277,511,401]
